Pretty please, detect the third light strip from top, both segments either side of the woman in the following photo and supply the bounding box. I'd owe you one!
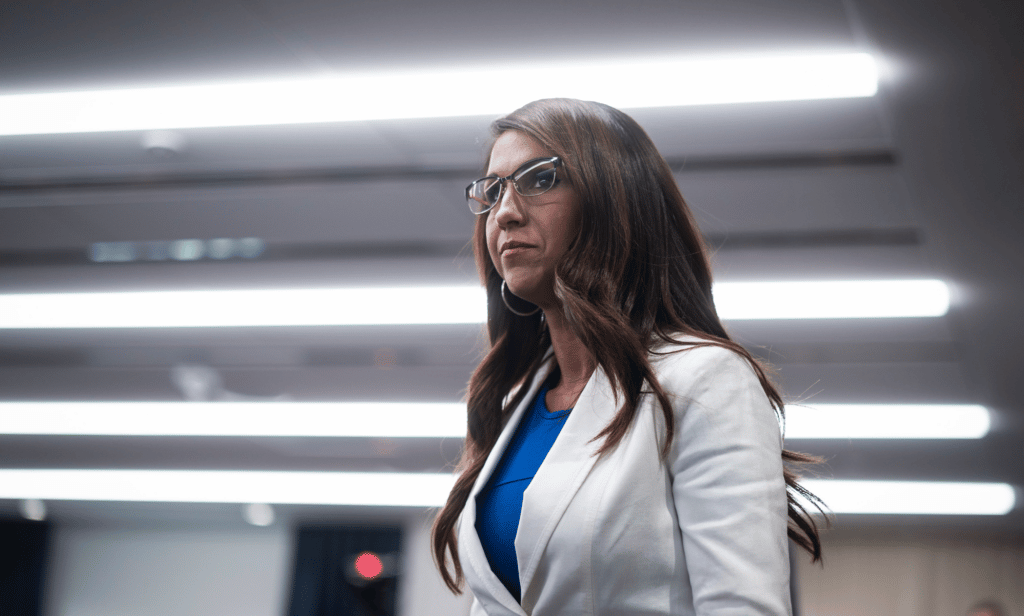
[0,401,990,440]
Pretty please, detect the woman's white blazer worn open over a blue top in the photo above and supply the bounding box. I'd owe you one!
[457,339,792,616]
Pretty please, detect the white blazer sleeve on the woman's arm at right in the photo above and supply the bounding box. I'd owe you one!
[660,347,792,616]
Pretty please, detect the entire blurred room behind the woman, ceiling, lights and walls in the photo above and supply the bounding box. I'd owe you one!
[0,0,1024,616]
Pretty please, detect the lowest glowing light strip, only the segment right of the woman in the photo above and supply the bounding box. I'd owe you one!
[801,479,1016,516]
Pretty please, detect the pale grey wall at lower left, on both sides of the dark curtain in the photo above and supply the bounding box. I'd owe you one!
[39,512,472,616]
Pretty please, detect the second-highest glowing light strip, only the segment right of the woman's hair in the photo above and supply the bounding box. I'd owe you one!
[714,279,949,320]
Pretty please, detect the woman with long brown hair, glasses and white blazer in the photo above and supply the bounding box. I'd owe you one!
[433,99,820,616]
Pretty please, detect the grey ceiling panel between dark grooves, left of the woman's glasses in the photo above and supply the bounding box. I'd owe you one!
[0,180,473,245]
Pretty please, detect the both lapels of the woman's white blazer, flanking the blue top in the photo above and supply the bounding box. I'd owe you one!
[459,350,618,616]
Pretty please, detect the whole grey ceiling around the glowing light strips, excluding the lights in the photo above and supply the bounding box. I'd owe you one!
[0,0,1024,532]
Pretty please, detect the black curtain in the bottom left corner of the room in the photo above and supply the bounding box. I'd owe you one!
[0,520,50,616]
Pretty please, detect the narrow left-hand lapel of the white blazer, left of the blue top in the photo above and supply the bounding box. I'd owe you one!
[458,350,552,616]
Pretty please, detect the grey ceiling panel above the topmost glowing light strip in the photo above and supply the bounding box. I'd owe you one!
[0,0,855,92]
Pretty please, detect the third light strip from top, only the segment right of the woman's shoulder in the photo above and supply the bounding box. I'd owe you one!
[782,404,991,440]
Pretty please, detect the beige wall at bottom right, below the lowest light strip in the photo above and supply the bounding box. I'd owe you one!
[797,521,1024,616]
